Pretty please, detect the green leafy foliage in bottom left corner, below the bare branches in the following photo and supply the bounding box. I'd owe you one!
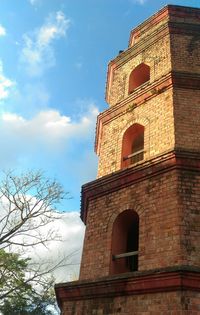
[0,249,57,315]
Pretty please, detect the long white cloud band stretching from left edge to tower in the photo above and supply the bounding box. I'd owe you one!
[0,105,98,145]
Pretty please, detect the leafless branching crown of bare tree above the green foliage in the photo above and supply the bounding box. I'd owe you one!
[0,171,66,252]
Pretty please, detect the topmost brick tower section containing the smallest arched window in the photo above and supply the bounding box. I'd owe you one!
[106,5,200,106]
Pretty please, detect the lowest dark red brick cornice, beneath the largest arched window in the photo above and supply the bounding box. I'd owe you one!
[55,266,200,306]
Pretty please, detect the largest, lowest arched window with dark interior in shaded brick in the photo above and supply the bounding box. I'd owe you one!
[110,210,139,274]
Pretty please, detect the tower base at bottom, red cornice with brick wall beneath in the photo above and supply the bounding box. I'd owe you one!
[55,266,200,315]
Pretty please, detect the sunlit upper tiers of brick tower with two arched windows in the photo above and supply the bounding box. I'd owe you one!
[96,5,200,177]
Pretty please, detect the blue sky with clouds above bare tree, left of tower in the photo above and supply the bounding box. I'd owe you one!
[0,0,200,211]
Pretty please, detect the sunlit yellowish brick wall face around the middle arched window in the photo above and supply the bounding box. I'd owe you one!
[98,89,175,177]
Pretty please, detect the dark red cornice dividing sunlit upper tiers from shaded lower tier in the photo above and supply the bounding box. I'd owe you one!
[81,150,200,224]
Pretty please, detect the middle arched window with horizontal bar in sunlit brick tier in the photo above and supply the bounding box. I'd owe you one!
[121,124,144,168]
